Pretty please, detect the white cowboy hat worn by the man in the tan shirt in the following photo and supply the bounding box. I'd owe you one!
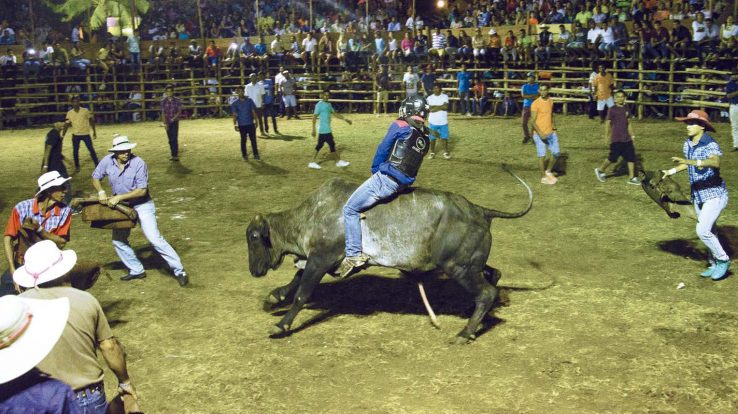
[13,240,77,288]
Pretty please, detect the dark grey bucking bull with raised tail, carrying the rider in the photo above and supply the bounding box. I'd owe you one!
[246,167,533,343]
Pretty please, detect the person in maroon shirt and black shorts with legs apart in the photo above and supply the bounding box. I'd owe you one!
[595,90,641,185]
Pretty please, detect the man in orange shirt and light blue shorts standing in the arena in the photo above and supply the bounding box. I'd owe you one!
[530,85,559,185]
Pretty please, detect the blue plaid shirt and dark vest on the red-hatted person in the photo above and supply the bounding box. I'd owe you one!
[683,132,728,204]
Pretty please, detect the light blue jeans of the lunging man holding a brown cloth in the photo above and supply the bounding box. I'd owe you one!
[113,200,183,275]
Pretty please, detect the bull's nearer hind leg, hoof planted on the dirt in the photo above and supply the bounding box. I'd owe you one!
[446,265,497,343]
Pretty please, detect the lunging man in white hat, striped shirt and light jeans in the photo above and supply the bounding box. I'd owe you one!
[92,135,189,287]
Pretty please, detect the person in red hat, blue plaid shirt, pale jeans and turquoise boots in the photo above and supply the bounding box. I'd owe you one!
[663,110,730,280]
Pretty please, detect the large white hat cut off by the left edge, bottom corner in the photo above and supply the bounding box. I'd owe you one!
[0,295,69,384]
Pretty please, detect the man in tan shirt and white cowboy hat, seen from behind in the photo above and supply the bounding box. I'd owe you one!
[13,240,138,414]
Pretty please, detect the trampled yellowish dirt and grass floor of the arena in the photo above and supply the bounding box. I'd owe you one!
[0,111,738,413]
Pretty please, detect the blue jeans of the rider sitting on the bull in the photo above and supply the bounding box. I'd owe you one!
[343,172,400,256]
